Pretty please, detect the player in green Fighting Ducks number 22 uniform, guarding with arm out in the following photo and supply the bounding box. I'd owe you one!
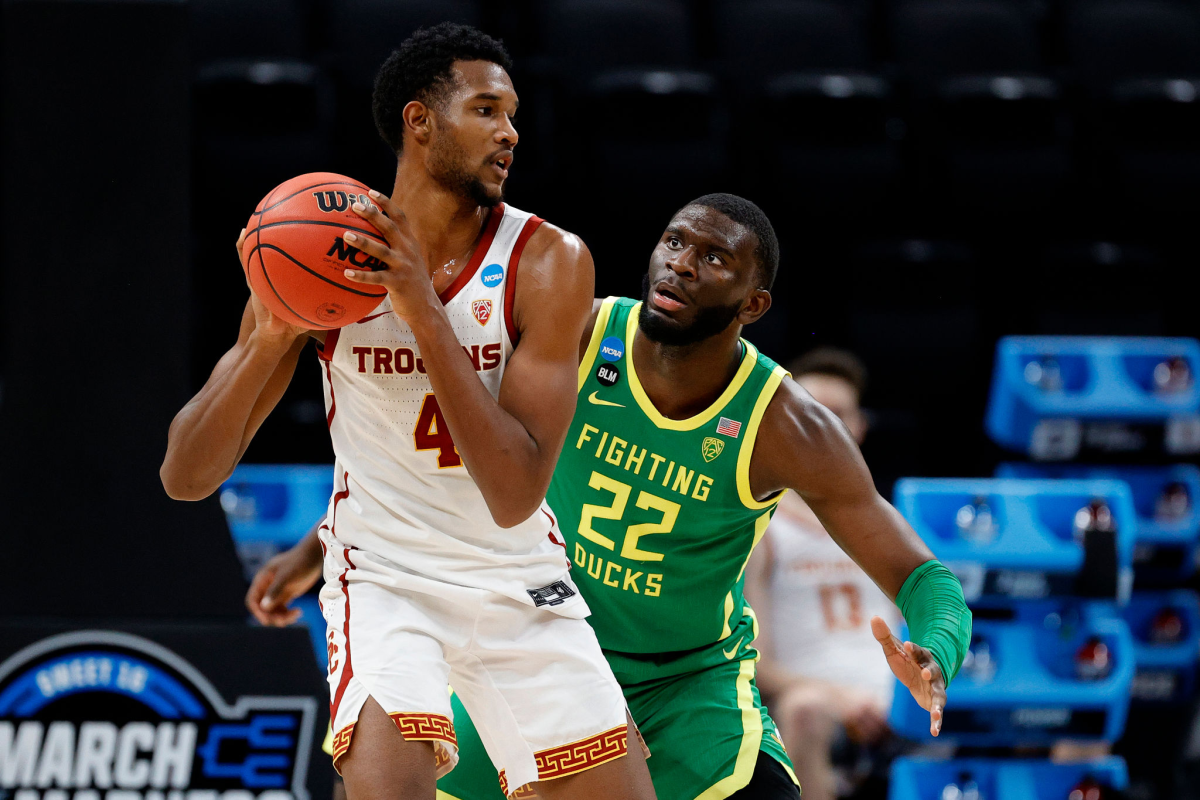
[251,194,971,800]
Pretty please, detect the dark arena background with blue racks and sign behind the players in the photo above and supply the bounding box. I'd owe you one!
[0,0,1200,800]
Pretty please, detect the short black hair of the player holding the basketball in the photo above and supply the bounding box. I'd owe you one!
[371,23,512,154]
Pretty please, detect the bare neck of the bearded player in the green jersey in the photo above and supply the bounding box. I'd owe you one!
[632,325,744,420]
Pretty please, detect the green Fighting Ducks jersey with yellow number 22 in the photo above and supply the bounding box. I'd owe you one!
[547,297,787,654]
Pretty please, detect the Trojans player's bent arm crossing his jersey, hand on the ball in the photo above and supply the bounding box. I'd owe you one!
[346,192,595,528]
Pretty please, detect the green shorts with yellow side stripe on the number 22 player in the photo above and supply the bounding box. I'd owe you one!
[438,645,796,800]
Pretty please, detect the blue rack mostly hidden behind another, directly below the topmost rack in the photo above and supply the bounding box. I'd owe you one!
[996,463,1200,585]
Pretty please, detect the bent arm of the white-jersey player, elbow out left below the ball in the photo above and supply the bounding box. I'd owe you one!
[158,299,307,500]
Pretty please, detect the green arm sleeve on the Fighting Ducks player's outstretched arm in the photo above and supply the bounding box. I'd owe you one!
[896,559,971,686]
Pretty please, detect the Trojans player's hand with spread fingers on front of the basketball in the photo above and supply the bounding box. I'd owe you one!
[342,190,438,319]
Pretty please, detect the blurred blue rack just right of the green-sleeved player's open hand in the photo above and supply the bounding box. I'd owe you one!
[889,601,1134,747]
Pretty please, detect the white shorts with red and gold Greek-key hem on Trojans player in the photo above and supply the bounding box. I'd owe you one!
[320,530,626,794]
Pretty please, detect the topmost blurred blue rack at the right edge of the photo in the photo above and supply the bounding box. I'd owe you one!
[985,336,1200,461]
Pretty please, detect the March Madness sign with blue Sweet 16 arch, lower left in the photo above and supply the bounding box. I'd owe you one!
[0,628,329,800]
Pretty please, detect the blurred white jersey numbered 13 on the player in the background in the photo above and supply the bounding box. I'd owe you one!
[767,499,900,706]
